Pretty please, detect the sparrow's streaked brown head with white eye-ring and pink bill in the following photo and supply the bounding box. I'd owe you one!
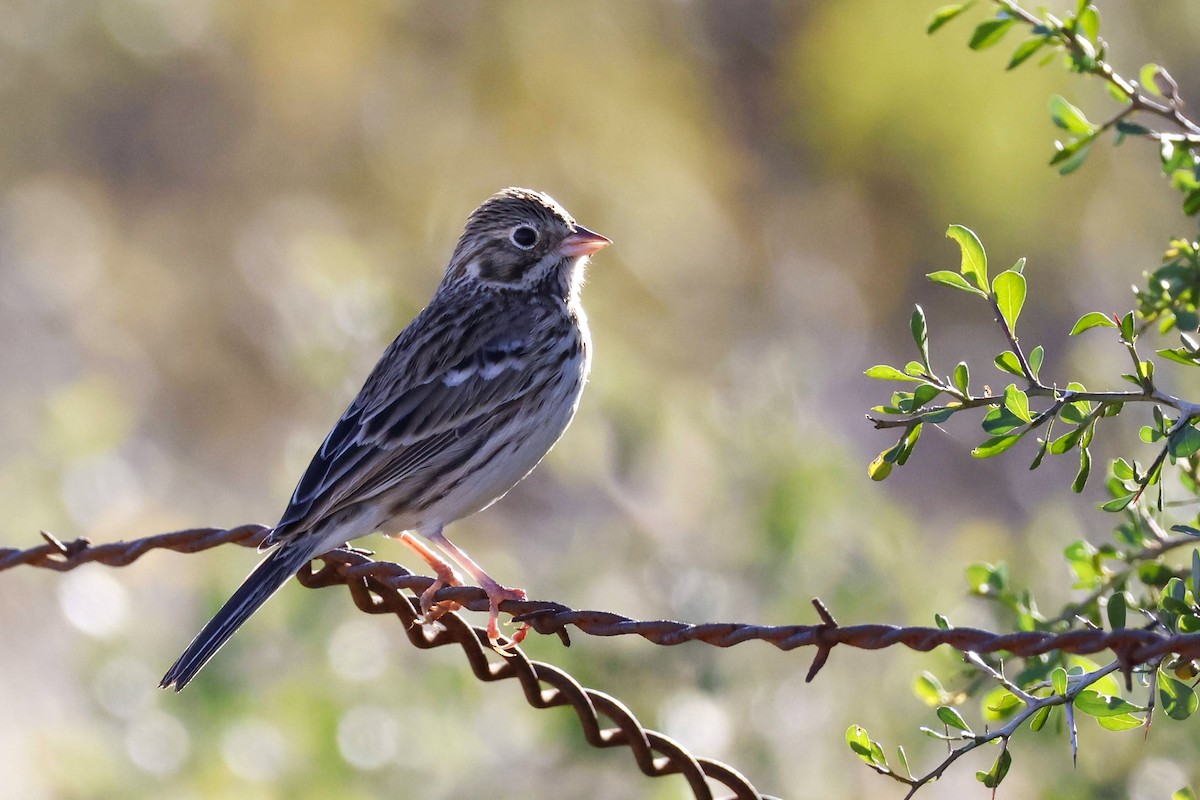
[445,188,612,299]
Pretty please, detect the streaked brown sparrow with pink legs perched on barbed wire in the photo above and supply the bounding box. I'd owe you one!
[160,187,612,692]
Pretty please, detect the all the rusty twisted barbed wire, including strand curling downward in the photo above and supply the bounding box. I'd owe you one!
[9,525,1200,800]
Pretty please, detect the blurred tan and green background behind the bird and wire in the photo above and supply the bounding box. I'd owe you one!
[0,0,1200,800]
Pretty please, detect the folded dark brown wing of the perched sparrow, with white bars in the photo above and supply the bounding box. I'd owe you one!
[270,302,544,543]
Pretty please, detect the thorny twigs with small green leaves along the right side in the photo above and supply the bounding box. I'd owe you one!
[847,0,1200,800]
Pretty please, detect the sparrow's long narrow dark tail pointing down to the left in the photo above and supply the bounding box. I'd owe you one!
[158,542,316,692]
